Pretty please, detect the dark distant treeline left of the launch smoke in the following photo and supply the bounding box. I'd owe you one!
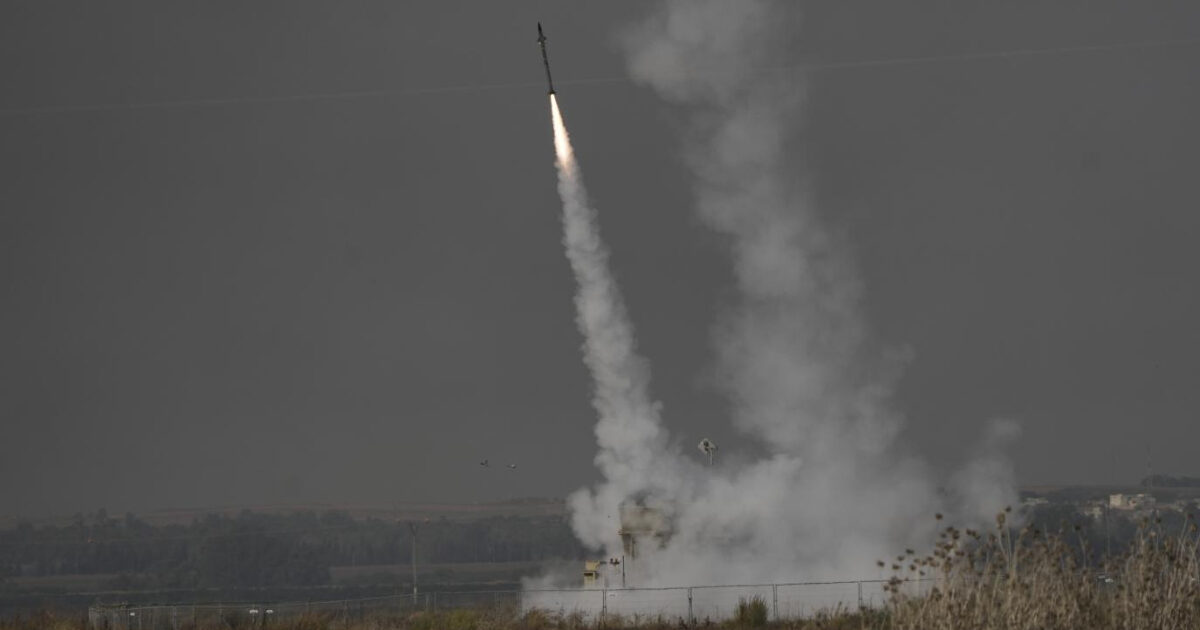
[0,510,584,588]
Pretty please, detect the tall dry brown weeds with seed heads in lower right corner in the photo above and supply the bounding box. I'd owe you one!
[884,510,1200,630]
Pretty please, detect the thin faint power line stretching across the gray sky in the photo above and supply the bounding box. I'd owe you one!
[0,38,1200,116]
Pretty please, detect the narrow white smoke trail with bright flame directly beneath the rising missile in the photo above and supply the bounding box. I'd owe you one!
[550,95,681,548]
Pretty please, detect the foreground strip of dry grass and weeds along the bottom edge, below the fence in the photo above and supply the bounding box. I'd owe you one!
[9,512,1200,630]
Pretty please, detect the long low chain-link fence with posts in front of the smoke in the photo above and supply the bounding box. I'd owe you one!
[88,580,928,630]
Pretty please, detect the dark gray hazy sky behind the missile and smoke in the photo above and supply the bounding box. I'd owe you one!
[0,0,1200,515]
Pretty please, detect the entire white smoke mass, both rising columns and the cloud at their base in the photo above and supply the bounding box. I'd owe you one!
[553,0,1013,586]
